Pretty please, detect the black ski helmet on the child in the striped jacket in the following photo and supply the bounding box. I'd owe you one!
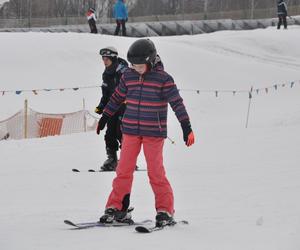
[127,39,156,65]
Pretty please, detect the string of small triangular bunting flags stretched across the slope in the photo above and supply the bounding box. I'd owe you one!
[0,80,300,98]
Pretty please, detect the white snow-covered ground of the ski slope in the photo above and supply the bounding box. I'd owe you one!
[0,27,300,250]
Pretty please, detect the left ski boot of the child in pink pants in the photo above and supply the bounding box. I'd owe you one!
[99,207,134,225]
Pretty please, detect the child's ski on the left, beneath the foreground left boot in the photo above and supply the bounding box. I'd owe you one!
[64,220,152,229]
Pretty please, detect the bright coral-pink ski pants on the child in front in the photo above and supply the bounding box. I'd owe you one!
[106,134,174,214]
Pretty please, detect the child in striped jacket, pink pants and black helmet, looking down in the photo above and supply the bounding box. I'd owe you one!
[98,39,194,227]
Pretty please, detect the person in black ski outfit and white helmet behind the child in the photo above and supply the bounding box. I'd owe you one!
[95,47,128,171]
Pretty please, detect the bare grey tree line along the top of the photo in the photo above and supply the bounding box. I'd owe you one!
[0,0,300,18]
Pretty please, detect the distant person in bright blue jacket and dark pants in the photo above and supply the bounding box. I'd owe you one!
[113,0,128,36]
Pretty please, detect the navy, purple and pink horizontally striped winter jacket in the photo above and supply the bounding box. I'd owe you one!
[103,63,189,138]
